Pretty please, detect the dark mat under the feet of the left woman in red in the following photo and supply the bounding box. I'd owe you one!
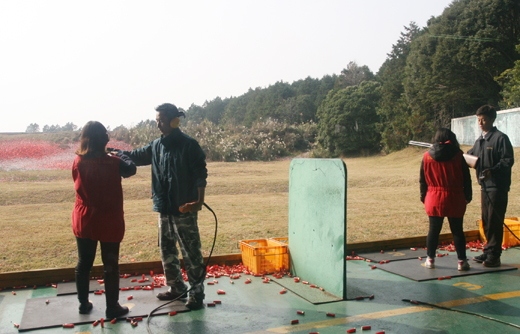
[19,288,189,331]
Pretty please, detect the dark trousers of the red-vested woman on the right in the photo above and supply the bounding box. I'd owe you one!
[426,216,466,260]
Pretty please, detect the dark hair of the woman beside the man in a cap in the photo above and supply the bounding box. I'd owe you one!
[76,121,109,157]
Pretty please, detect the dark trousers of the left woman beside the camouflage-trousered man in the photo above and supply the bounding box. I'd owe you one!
[76,237,120,307]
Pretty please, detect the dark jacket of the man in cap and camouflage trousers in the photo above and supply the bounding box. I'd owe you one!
[118,128,208,216]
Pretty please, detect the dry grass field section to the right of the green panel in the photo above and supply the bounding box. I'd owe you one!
[345,147,520,242]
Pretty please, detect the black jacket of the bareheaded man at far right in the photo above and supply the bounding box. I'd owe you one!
[468,127,515,191]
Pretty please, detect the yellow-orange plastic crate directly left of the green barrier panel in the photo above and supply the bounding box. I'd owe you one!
[240,239,289,274]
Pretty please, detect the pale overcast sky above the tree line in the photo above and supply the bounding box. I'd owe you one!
[0,0,452,132]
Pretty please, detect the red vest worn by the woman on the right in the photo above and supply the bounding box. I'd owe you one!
[421,150,471,218]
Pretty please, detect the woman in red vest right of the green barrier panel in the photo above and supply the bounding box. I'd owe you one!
[420,128,472,270]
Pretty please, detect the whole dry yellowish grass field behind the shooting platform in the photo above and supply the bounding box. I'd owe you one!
[0,147,520,272]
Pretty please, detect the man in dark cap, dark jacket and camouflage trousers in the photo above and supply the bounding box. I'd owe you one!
[115,103,208,310]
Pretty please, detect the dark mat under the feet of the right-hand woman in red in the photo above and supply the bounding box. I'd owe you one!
[370,254,517,282]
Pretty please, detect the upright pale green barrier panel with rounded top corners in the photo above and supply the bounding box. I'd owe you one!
[289,159,347,299]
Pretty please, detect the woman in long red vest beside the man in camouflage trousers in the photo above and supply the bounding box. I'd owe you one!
[72,121,136,319]
